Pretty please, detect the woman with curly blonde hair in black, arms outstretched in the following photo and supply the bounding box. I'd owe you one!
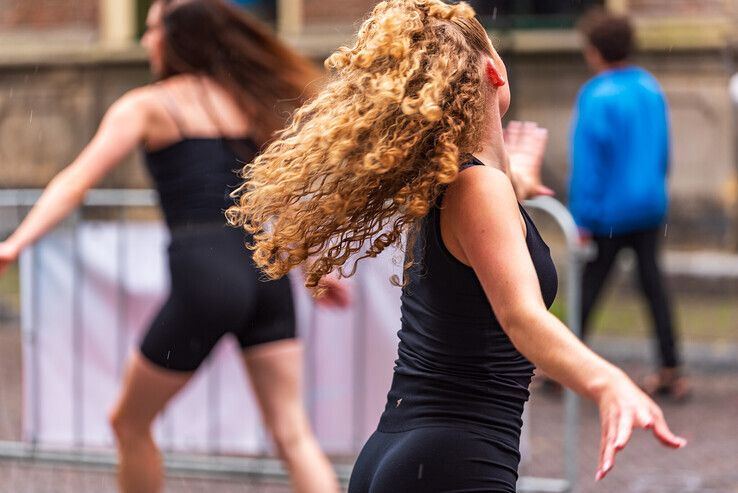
[229,0,686,493]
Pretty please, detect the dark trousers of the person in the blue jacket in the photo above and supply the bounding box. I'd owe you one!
[582,228,679,368]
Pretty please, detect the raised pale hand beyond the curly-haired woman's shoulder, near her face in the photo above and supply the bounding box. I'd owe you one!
[503,121,554,200]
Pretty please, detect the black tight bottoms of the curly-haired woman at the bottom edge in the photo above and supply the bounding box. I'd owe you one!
[348,426,520,493]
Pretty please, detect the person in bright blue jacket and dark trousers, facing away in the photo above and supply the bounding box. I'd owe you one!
[569,9,688,398]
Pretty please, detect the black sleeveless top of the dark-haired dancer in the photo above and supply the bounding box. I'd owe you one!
[145,137,258,229]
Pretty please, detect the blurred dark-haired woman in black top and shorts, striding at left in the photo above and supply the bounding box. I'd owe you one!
[0,0,345,493]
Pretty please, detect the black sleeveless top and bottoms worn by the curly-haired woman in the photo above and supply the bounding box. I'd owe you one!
[349,160,558,493]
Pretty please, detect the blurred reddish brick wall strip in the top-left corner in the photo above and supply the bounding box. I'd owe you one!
[0,0,98,30]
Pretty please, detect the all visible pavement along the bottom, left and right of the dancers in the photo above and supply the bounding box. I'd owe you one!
[0,318,738,493]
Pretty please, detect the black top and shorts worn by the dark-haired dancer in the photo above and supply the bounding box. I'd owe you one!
[140,138,295,372]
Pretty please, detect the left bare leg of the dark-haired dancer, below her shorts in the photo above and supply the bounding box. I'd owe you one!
[110,352,192,493]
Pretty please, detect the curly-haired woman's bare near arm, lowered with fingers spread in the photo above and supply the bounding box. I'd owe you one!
[443,166,685,479]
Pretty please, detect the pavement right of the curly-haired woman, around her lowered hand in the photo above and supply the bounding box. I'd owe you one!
[521,362,738,493]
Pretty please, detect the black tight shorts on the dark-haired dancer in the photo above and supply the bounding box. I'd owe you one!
[141,225,295,372]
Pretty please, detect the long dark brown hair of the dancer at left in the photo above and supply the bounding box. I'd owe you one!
[157,0,320,143]
